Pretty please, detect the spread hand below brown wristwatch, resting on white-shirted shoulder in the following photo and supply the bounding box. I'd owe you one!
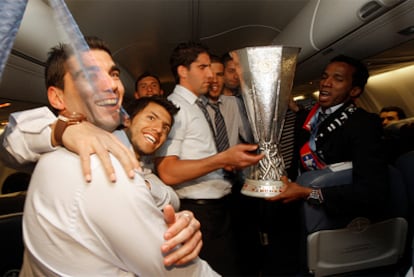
[62,121,141,182]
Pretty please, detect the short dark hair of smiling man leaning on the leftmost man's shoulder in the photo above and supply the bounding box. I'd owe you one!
[126,95,180,126]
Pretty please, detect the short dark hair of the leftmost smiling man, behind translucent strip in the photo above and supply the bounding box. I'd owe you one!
[45,36,112,90]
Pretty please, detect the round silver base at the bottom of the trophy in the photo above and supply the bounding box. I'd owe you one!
[241,179,283,198]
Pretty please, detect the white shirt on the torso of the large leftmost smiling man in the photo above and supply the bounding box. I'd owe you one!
[21,147,218,276]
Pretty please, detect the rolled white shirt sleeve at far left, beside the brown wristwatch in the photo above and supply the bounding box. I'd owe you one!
[0,107,56,168]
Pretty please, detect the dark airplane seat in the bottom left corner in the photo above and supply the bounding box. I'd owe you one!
[0,212,24,276]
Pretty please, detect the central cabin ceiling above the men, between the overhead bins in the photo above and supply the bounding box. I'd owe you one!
[67,0,309,86]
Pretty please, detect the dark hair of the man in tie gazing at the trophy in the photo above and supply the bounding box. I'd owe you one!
[170,41,208,84]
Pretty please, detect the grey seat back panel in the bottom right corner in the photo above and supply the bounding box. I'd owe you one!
[308,217,407,276]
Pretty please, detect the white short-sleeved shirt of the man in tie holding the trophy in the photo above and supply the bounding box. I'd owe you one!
[156,85,231,199]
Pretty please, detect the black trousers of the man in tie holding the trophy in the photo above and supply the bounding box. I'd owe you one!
[181,196,239,276]
